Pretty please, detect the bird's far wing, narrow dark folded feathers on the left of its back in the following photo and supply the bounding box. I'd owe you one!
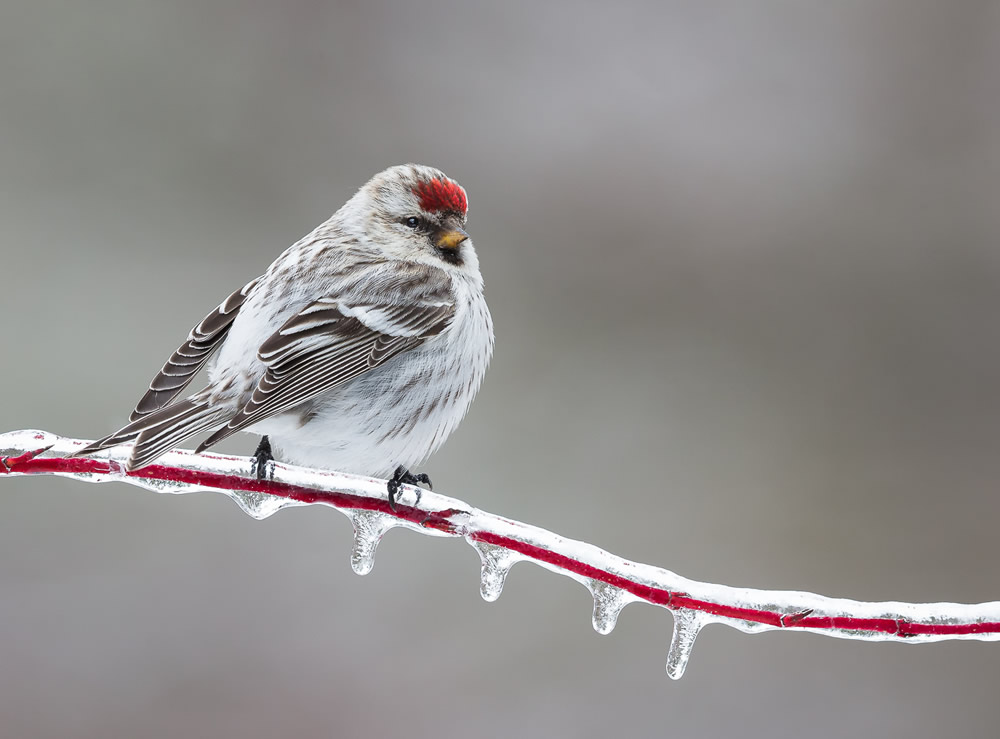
[129,277,260,421]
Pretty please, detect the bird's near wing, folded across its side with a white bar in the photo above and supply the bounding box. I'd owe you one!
[198,297,455,452]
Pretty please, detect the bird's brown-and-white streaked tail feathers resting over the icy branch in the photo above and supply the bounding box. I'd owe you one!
[73,393,233,470]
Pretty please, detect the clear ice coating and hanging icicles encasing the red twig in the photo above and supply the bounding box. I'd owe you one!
[0,430,1000,680]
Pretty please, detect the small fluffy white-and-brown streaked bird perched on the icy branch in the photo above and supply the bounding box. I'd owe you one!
[77,164,493,508]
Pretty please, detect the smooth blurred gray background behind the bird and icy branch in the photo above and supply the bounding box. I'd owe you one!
[0,0,1000,739]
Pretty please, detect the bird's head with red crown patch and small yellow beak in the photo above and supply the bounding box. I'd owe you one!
[342,164,476,269]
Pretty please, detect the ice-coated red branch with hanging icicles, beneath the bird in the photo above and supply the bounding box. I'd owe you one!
[0,431,1000,679]
